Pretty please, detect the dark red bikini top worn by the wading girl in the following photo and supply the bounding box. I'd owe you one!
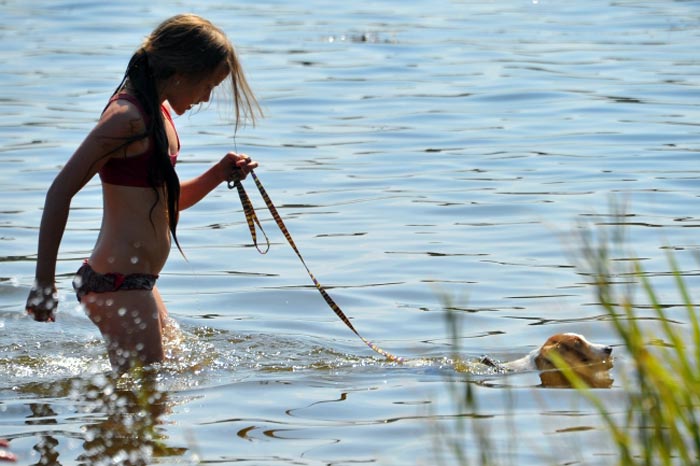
[99,94,180,188]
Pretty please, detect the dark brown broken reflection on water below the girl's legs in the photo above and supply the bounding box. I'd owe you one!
[14,373,187,466]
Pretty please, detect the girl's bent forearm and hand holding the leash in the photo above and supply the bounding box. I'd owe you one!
[180,152,258,210]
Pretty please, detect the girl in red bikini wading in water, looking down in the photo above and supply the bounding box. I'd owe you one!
[26,15,261,372]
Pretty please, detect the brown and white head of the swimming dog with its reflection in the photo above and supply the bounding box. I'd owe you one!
[535,333,613,388]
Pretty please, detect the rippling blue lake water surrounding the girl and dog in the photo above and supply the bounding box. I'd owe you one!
[0,0,700,466]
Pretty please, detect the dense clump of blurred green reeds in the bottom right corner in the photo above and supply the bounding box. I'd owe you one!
[559,217,700,466]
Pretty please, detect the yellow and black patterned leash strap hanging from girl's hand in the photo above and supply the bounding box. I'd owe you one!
[228,171,403,362]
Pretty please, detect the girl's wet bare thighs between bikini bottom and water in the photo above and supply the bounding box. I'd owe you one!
[83,288,168,373]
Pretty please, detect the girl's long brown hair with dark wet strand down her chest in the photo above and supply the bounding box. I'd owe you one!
[113,14,262,253]
